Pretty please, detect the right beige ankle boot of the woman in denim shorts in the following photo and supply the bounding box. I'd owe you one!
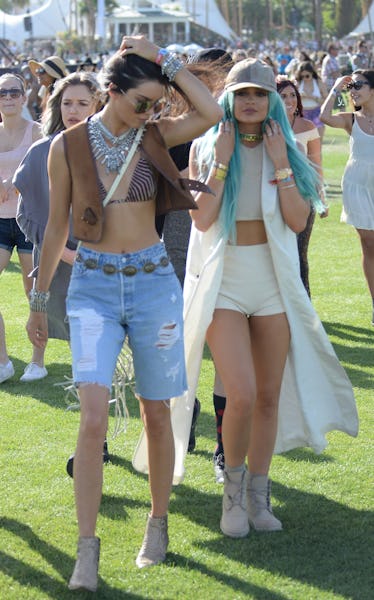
[136,515,169,569]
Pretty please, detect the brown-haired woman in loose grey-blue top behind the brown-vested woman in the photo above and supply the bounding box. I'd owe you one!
[13,72,101,352]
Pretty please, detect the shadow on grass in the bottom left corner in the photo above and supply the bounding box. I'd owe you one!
[0,518,144,600]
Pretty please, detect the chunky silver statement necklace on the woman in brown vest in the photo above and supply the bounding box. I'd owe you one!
[88,116,137,173]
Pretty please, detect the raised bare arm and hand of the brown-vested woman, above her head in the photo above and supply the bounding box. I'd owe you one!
[120,36,223,147]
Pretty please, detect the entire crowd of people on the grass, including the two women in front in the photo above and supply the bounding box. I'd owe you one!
[0,36,366,591]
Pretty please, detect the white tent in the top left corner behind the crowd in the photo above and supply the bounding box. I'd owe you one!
[0,0,70,46]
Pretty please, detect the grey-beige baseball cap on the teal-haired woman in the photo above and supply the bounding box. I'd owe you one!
[225,58,277,92]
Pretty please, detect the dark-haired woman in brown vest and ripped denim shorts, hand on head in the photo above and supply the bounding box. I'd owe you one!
[28,36,222,591]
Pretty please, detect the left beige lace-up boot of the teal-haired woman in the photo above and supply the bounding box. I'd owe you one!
[220,465,249,537]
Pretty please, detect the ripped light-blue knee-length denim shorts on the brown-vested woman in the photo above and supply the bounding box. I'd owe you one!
[67,243,187,400]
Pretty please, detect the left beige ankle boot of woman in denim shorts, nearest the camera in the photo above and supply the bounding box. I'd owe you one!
[68,537,100,592]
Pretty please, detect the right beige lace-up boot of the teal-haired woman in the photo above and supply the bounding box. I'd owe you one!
[247,475,282,531]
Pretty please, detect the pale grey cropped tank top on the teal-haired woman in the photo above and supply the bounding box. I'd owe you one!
[236,143,263,221]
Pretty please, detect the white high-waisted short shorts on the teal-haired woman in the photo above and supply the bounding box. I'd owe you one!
[216,244,285,316]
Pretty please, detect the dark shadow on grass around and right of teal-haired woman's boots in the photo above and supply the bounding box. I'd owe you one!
[171,483,374,600]
